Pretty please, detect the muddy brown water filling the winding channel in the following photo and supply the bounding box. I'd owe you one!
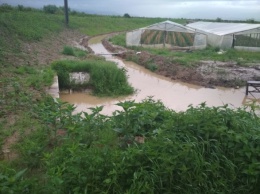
[60,36,258,115]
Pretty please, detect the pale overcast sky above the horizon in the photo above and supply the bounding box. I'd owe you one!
[0,0,260,21]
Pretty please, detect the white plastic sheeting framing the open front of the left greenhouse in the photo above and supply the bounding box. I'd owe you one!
[126,21,207,49]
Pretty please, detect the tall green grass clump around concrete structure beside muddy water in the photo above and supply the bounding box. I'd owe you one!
[52,60,134,96]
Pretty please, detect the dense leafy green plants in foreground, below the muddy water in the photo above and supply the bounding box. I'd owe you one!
[0,98,260,194]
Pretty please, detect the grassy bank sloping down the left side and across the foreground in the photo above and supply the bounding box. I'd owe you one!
[0,4,260,194]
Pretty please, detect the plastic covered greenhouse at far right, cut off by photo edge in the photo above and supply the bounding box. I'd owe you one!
[187,22,260,51]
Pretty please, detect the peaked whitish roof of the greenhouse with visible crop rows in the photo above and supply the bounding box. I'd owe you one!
[142,20,196,33]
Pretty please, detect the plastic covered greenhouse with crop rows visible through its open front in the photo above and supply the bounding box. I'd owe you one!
[126,21,207,49]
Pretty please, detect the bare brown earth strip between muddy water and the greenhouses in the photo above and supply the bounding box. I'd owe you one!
[102,40,260,88]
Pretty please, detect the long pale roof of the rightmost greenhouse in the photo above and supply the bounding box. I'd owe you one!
[187,22,260,36]
